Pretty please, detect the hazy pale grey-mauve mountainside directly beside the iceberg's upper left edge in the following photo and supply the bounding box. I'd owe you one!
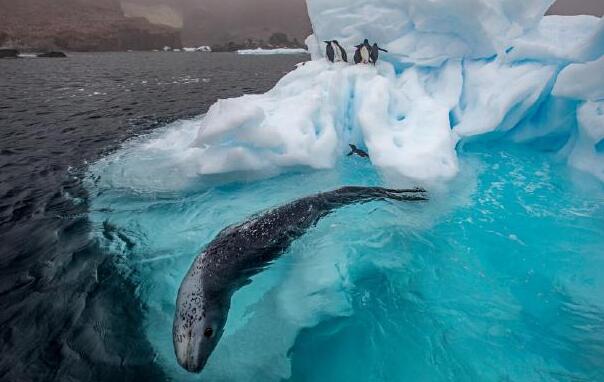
[122,0,312,46]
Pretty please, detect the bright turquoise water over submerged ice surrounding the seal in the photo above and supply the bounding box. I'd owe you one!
[89,121,604,381]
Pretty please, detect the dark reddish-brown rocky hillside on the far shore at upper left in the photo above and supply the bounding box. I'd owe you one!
[0,0,182,51]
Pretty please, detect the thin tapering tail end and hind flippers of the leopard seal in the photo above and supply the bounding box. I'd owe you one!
[322,186,428,209]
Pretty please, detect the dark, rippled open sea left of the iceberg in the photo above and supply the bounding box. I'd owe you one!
[0,53,305,381]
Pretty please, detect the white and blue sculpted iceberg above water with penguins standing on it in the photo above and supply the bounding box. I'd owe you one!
[190,0,604,181]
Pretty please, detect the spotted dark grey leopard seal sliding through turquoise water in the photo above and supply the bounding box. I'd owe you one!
[173,187,426,372]
